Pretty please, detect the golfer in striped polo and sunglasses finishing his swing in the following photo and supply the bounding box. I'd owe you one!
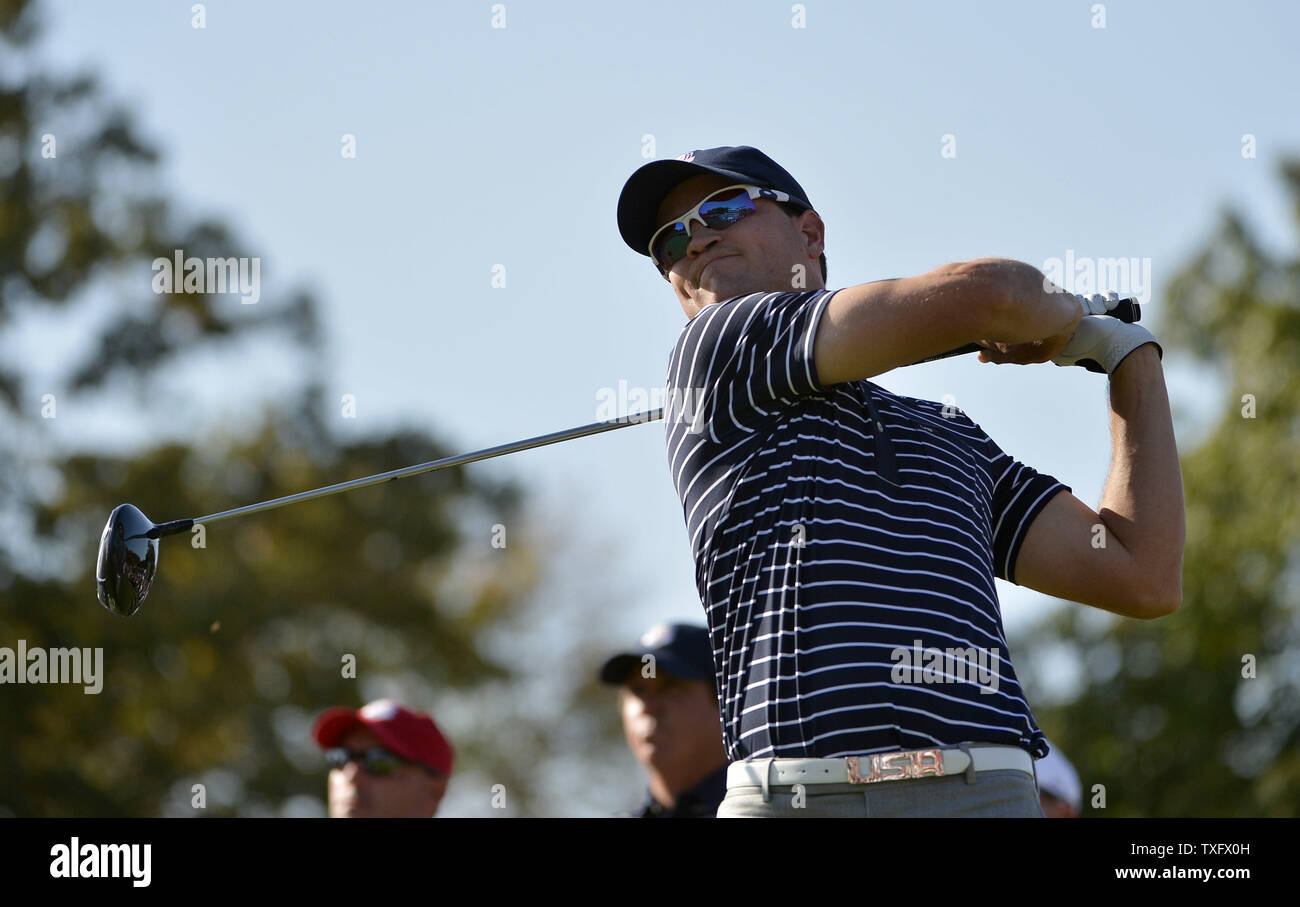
[618,147,1184,817]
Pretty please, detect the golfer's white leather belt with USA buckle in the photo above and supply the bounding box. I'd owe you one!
[727,745,1035,790]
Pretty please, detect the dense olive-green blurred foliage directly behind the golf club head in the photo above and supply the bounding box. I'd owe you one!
[0,413,538,816]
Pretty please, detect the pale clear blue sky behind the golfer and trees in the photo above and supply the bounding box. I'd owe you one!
[20,0,1300,779]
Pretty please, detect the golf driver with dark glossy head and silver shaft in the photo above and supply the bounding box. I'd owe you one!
[95,299,1141,617]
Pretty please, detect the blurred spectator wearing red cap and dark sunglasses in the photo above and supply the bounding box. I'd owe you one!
[312,699,452,819]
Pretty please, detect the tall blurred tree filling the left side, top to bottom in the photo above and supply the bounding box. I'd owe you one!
[0,0,629,816]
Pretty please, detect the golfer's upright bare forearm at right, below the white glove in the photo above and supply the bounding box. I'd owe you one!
[1099,343,1187,604]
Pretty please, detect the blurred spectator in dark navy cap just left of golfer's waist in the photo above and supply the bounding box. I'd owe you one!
[601,624,727,819]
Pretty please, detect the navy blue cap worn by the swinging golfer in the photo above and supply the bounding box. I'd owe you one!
[619,146,813,259]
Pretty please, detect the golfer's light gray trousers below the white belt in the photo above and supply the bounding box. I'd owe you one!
[718,768,1044,819]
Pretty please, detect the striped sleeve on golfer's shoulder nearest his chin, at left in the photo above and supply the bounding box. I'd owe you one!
[668,290,832,441]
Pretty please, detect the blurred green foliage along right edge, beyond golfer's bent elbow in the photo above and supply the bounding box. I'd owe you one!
[1017,162,1300,817]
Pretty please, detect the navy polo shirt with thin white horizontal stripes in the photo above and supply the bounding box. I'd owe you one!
[666,290,1070,761]
